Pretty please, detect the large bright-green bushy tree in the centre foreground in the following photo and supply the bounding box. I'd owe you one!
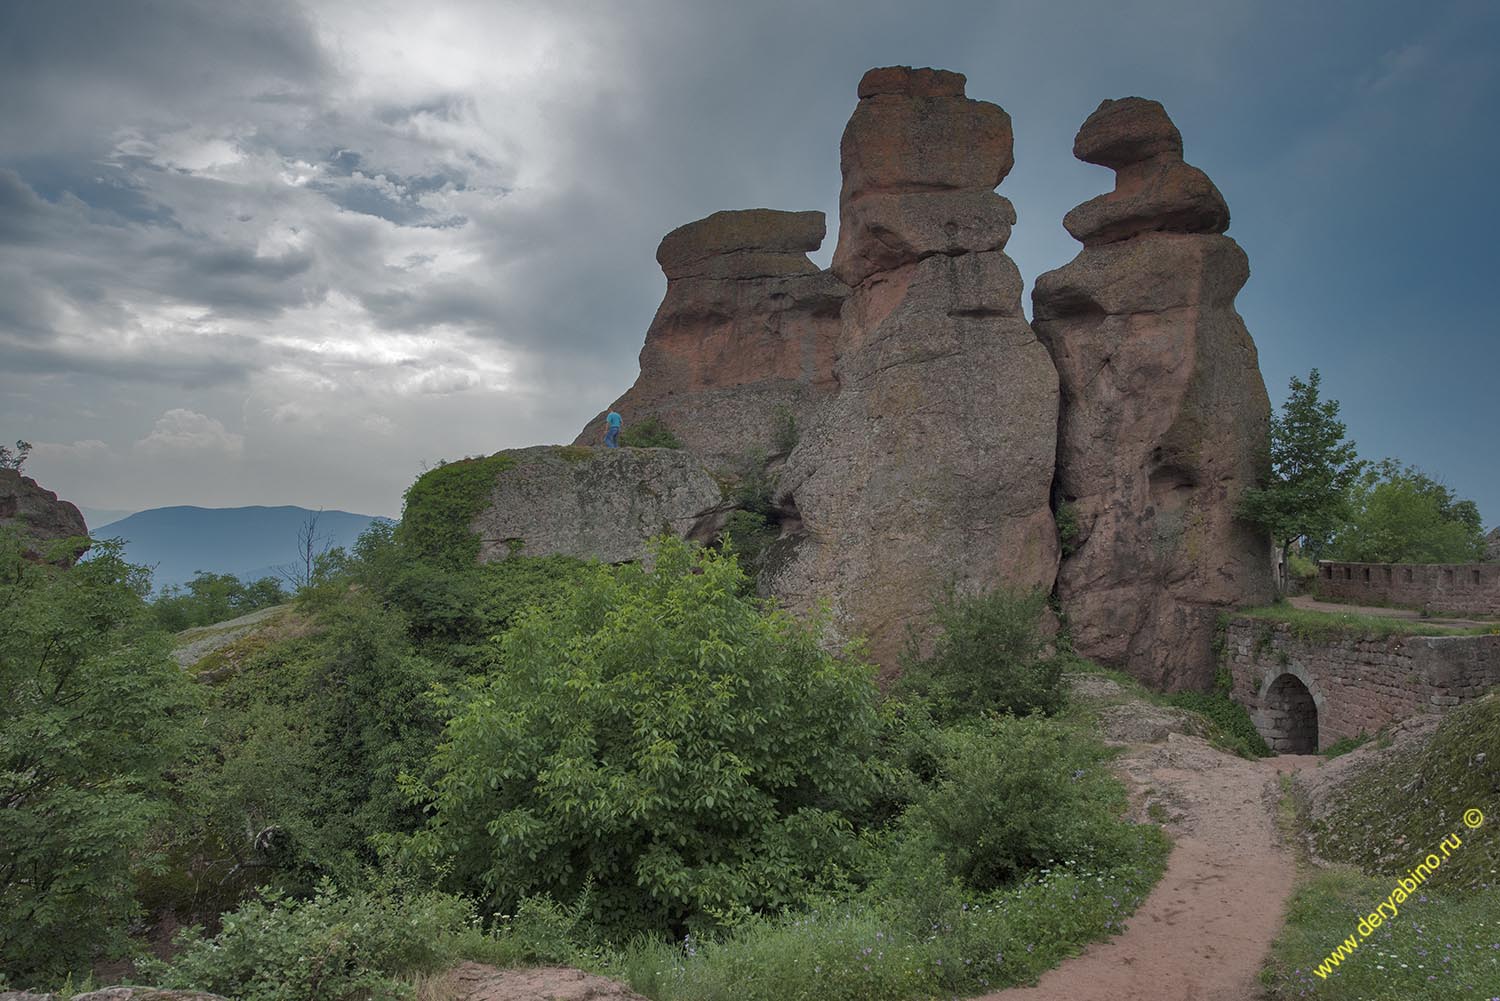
[414,537,876,932]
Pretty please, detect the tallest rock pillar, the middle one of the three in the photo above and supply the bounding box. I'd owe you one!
[762,68,1058,668]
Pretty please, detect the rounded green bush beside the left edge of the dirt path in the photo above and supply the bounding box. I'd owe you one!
[888,716,1134,900]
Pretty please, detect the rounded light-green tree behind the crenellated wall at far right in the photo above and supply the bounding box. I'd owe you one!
[1329,459,1485,563]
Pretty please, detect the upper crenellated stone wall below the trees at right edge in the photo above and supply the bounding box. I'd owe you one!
[1317,561,1500,615]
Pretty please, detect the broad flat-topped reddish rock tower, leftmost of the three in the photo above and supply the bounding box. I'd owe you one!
[576,209,849,468]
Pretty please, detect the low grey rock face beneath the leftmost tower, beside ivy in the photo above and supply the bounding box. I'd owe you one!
[470,446,723,563]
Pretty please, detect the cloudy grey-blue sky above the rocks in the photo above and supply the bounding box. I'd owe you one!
[0,0,1500,525]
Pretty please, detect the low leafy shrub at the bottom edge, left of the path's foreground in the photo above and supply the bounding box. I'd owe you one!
[141,882,474,1001]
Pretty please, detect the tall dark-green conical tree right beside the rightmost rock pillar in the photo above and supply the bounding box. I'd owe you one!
[1239,369,1365,587]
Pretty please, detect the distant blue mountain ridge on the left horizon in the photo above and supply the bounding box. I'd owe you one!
[89,506,390,590]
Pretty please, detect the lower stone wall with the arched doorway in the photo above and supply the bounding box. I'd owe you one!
[1223,617,1500,752]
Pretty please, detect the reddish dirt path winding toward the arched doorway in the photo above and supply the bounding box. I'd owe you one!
[984,734,1317,1001]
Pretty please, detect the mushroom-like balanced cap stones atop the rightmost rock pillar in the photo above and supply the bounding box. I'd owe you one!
[1062,98,1229,246]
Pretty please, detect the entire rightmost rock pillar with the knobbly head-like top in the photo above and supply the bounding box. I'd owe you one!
[1032,98,1274,689]
